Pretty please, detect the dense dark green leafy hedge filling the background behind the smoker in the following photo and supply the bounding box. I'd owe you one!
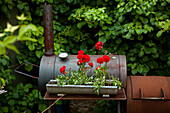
[0,0,170,113]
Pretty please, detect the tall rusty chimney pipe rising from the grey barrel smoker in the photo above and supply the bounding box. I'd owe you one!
[43,5,54,56]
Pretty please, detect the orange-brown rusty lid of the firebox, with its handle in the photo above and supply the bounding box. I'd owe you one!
[130,76,170,100]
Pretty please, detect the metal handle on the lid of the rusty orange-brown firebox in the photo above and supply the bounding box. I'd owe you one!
[139,88,166,100]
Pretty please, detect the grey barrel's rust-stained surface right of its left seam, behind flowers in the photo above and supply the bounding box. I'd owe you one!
[54,55,127,82]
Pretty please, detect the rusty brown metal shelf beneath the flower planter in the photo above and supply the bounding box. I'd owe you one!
[44,88,127,100]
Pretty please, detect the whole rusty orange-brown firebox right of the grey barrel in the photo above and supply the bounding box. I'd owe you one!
[127,76,170,113]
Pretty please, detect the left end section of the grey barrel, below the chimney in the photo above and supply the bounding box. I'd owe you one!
[39,56,56,94]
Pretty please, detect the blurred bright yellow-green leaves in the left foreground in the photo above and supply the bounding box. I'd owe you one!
[0,14,38,56]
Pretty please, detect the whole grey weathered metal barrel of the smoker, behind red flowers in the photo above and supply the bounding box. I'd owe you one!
[39,55,127,94]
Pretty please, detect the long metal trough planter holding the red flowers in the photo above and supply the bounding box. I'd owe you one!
[46,80,118,95]
